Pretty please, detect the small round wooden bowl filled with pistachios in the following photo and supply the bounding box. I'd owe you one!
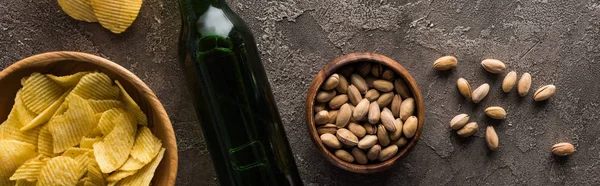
[305,53,424,173]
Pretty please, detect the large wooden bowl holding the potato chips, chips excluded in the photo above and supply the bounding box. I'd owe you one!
[0,52,177,186]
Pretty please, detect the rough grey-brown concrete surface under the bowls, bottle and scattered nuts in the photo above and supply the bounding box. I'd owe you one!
[0,0,600,185]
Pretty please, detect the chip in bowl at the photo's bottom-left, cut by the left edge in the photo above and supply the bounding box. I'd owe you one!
[0,140,37,185]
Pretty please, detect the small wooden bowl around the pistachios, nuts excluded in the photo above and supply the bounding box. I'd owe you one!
[305,53,425,173]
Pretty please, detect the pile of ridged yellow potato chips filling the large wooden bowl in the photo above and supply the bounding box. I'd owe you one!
[0,72,165,186]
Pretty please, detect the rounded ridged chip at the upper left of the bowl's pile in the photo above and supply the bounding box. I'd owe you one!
[21,73,64,114]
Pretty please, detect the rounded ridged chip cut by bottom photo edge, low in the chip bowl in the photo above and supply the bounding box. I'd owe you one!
[38,156,79,185]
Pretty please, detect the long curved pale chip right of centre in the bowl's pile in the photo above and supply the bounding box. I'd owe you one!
[94,114,137,173]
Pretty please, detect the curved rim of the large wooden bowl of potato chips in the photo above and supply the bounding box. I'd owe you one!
[0,51,179,186]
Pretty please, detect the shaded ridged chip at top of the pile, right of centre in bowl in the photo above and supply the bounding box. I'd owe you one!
[72,72,119,100]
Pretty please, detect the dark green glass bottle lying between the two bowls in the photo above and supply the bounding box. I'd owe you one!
[179,0,302,186]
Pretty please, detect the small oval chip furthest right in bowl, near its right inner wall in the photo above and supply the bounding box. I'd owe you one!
[131,126,162,164]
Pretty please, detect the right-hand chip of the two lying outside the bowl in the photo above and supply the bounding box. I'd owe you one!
[92,0,142,34]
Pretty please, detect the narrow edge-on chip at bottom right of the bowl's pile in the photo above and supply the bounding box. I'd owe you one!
[118,148,165,186]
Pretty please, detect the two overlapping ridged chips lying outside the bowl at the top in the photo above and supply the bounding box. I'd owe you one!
[58,0,142,34]
